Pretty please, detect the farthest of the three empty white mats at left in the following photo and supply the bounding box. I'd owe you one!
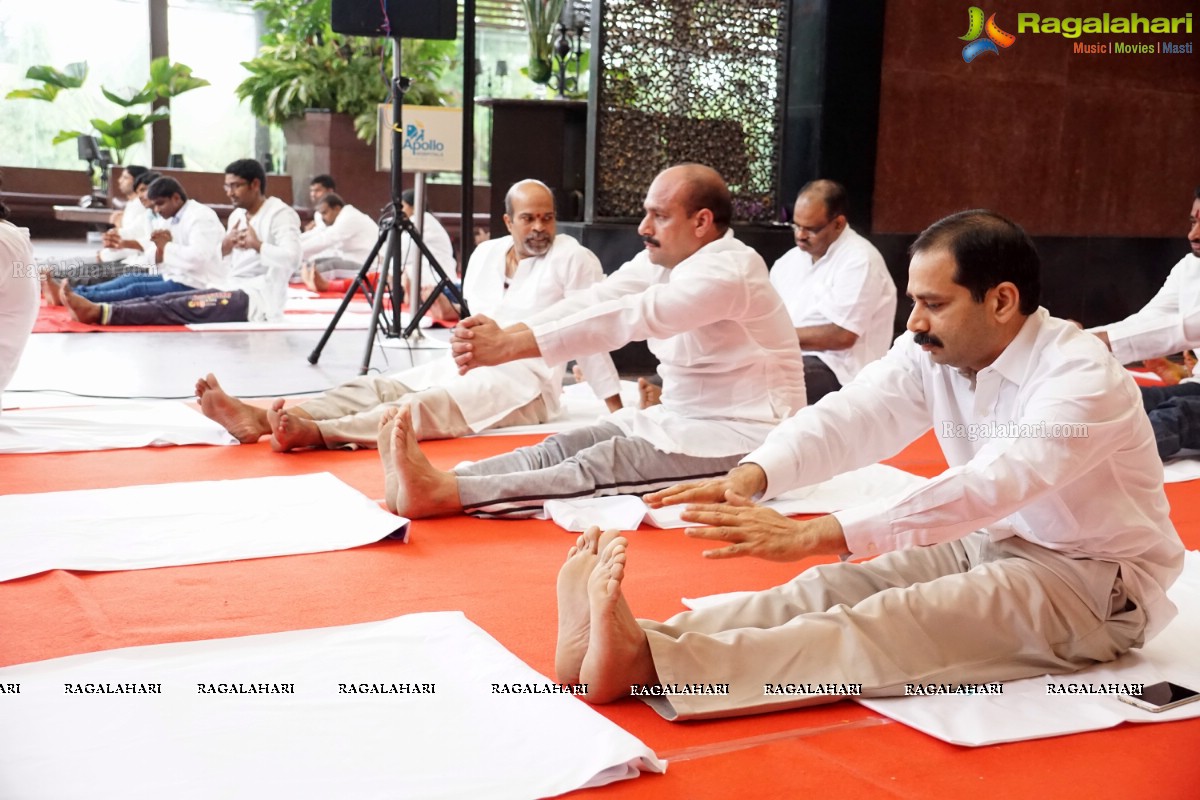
[0,395,238,453]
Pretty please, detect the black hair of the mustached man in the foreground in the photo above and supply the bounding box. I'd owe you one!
[908,209,1042,317]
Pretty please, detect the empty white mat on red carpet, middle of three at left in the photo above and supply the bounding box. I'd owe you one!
[0,473,408,585]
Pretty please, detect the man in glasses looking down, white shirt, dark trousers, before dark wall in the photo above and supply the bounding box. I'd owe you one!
[770,180,896,405]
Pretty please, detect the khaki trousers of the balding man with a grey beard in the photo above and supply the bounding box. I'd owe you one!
[296,375,548,447]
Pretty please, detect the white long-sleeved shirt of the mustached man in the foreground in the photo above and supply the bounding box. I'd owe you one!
[744,308,1183,638]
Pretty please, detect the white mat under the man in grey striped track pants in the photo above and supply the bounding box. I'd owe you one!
[544,464,925,531]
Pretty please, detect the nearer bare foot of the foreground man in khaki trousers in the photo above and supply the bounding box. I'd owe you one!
[580,536,659,703]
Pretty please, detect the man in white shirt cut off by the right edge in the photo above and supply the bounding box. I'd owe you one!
[1088,187,1200,459]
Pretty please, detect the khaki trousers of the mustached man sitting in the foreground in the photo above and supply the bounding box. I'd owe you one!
[638,533,1146,718]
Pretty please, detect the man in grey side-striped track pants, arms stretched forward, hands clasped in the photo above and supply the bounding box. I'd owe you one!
[389,164,804,517]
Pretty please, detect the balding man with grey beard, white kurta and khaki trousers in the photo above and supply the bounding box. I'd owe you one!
[196,181,620,452]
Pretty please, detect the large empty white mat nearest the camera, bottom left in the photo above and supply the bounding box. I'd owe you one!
[0,612,666,800]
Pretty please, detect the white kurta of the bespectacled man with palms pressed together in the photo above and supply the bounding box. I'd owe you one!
[223,197,300,323]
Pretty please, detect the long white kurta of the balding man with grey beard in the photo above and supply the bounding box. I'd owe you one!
[392,234,620,433]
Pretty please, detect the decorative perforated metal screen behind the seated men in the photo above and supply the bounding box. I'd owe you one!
[592,0,788,222]
